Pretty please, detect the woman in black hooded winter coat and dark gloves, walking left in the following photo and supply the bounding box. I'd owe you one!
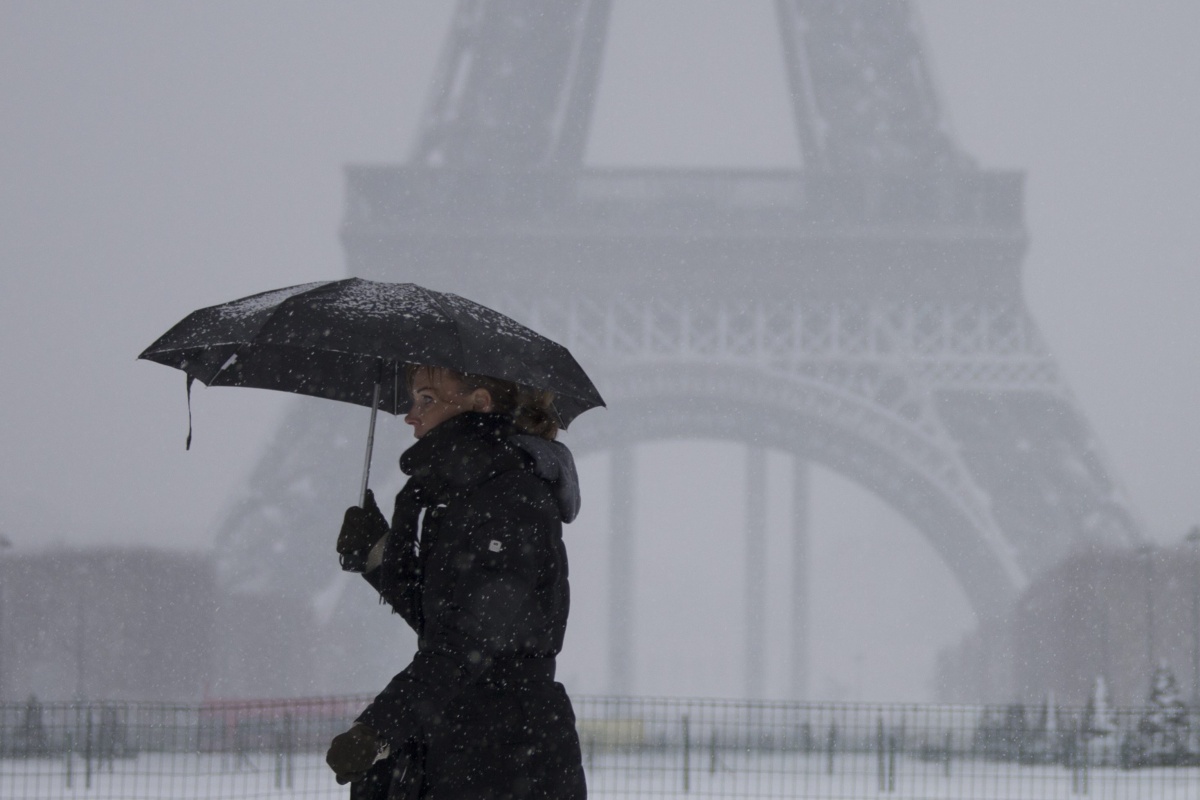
[326,367,587,800]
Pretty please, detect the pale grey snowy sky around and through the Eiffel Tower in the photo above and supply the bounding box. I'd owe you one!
[0,0,1200,699]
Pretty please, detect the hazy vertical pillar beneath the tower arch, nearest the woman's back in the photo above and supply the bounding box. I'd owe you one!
[608,444,635,696]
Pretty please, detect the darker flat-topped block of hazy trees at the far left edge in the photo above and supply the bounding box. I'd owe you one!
[0,547,216,702]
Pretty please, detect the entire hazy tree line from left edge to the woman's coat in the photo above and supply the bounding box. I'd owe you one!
[0,547,415,702]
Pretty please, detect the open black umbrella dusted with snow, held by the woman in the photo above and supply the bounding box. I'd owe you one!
[138,278,604,501]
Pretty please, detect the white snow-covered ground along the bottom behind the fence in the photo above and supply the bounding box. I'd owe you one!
[0,748,1200,800]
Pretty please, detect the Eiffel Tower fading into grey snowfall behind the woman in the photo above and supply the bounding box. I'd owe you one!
[211,0,1140,697]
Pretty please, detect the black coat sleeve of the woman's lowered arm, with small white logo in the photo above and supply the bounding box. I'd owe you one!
[358,501,544,747]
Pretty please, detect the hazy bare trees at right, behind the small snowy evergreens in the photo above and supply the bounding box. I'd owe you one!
[937,545,1200,705]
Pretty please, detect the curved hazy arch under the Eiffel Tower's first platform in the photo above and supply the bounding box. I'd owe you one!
[564,365,1027,619]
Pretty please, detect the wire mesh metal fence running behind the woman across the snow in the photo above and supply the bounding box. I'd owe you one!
[0,697,1200,800]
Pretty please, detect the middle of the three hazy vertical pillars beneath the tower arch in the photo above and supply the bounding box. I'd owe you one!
[745,446,767,699]
